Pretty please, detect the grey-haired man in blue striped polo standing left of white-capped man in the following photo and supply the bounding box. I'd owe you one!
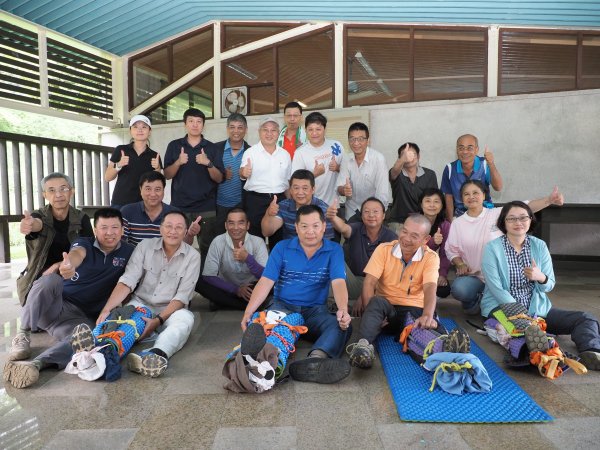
[214,113,250,235]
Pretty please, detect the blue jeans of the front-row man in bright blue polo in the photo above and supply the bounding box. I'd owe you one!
[269,300,352,358]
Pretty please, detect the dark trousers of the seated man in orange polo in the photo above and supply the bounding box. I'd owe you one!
[359,297,446,344]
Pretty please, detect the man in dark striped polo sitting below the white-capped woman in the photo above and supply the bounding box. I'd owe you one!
[121,171,201,247]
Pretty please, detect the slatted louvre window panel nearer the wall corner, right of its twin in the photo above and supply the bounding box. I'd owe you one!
[47,38,113,119]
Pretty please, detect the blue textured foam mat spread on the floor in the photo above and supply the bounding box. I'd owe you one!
[376,319,554,423]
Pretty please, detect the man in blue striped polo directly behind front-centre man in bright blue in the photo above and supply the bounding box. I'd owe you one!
[261,169,334,239]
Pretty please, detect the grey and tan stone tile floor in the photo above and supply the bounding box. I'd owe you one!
[0,262,600,450]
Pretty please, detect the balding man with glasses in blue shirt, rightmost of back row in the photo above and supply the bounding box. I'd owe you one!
[441,134,503,222]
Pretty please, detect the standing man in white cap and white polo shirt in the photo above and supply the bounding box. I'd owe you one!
[240,117,292,240]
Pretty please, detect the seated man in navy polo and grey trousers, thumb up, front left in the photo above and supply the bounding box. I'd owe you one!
[4,208,133,388]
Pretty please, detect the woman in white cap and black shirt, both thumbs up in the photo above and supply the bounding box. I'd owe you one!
[104,115,162,209]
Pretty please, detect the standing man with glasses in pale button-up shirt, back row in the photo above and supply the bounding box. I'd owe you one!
[337,122,389,223]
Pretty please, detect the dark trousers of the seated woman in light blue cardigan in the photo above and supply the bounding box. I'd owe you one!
[546,308,600,353]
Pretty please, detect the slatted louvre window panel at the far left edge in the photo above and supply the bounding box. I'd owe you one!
[0,21,40,105]
